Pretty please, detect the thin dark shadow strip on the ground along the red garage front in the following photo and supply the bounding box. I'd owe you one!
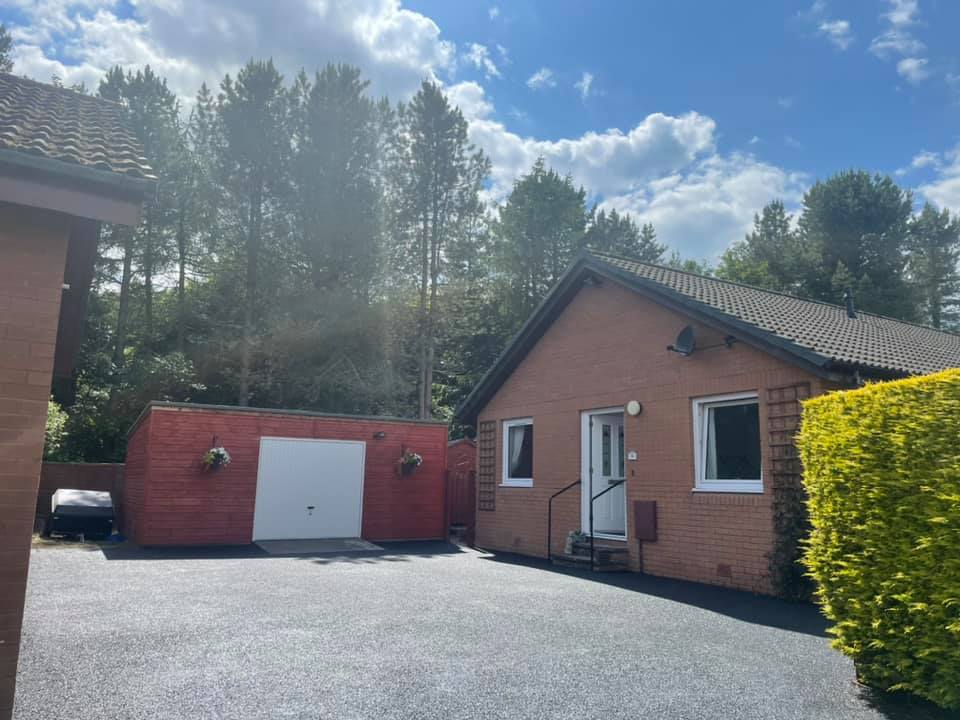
[94,540,463,565]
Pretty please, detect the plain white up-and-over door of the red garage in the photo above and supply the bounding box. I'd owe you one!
[253,437,366,540]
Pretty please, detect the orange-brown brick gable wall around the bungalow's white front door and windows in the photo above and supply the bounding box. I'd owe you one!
[477,282,821,592]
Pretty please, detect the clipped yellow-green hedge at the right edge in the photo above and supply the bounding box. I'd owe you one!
[799,370,960,708]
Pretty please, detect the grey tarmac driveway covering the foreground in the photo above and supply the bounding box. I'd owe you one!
[15,543,946,720]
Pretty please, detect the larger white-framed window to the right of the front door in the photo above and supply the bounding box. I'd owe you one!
[693,393,763,493]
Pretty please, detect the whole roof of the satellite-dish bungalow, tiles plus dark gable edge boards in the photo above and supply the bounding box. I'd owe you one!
[457,251,960,421]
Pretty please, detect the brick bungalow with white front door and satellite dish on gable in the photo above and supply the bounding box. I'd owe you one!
[458,252,960,593]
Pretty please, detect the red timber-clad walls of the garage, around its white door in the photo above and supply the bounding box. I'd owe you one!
[126,406,447,545]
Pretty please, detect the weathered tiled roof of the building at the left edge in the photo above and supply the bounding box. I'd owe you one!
[0,73,155,180]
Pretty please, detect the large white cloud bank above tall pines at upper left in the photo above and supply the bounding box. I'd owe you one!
[4,0,456,105]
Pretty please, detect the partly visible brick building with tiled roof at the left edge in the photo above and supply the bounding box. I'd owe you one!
[0,74,156,720]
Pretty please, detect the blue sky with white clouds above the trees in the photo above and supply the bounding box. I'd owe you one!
[0,0,960,258]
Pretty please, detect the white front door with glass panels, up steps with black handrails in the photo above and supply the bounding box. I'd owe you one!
[581,409,627,537]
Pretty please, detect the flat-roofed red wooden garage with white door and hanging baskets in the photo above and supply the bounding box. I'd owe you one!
[123,402,447,546]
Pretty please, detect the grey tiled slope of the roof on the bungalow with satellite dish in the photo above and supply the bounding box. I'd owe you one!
[591,252,960,375]
